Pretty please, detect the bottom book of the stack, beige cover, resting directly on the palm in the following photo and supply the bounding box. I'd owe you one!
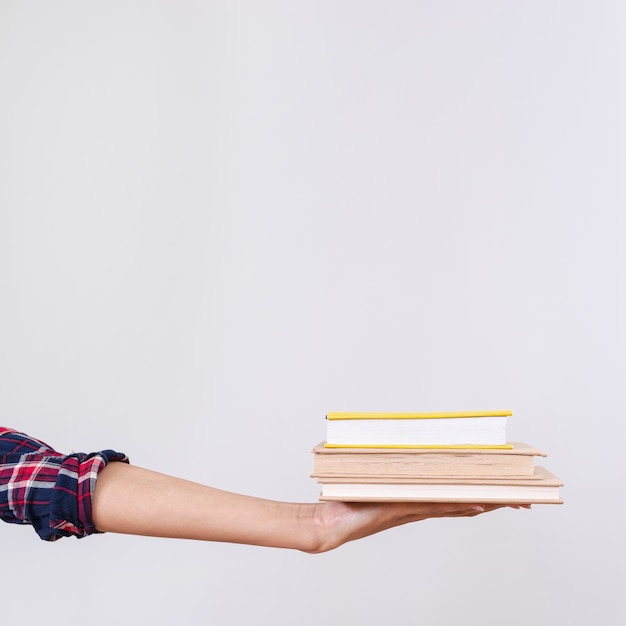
[319,467,563,504]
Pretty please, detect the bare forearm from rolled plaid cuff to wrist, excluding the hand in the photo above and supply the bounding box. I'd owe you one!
[93,463,320,551]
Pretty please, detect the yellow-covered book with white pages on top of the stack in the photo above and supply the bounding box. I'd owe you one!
[325,411,513,448]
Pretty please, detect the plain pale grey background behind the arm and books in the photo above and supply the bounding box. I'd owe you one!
[0,0,626,626]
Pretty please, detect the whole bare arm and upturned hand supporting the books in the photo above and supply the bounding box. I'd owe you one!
[93,462,518,553]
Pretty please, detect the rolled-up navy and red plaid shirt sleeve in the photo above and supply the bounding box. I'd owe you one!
[0,426,128,541]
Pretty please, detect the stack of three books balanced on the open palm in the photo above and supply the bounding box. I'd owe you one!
[312,411,563,504]
